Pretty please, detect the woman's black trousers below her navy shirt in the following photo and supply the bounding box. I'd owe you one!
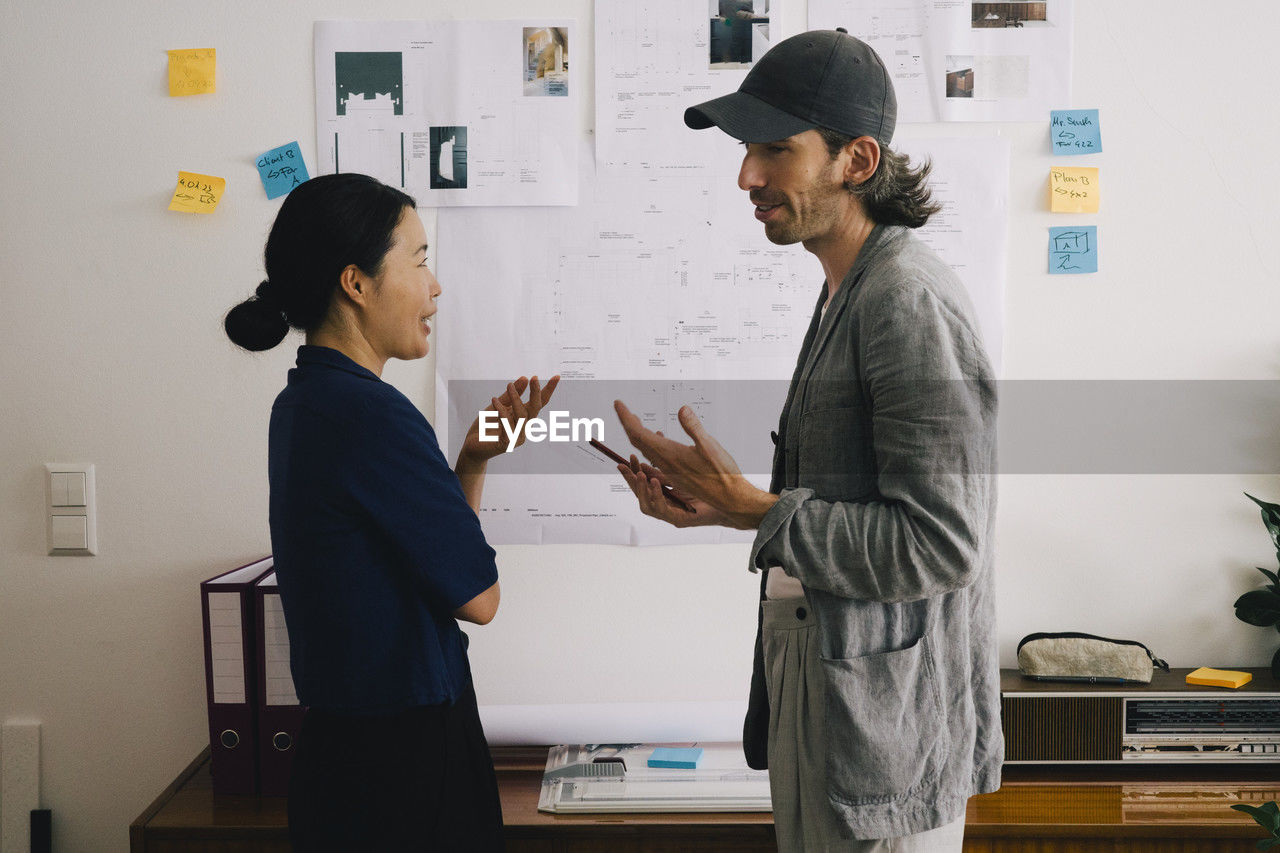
[289,684,503,853]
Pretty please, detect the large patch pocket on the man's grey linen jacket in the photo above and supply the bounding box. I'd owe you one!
[822,637,950,806]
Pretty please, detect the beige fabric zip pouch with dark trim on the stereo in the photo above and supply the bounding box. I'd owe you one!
[1018,631,1169,684]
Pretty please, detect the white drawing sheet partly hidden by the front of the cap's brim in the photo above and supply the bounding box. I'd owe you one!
[595,0,781,174]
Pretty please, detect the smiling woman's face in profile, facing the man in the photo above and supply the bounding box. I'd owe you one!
[365,207,440,361]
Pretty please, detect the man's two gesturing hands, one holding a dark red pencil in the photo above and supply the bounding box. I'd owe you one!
[613,400,778,530]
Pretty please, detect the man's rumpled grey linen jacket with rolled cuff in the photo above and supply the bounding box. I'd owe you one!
[744,225,1004,838]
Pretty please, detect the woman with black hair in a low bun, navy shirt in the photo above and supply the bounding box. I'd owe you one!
[225,174,559,850]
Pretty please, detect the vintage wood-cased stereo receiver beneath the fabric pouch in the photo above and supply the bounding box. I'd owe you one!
[1000,667,1280,765]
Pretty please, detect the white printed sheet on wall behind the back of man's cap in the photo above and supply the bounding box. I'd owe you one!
[809,0,1073,123]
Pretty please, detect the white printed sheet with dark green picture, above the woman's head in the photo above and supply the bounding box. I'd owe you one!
[315,19,588,207]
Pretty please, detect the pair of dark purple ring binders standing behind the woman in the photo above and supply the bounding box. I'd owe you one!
[200,557,302,797]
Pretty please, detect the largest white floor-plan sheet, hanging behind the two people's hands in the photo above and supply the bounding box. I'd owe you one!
[433,131,1009,544]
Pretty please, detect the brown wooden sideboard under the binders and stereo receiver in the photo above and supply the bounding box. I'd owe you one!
[129,749,1280,853]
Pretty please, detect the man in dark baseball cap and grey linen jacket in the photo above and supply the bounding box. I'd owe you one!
[616,31,1004,850]
